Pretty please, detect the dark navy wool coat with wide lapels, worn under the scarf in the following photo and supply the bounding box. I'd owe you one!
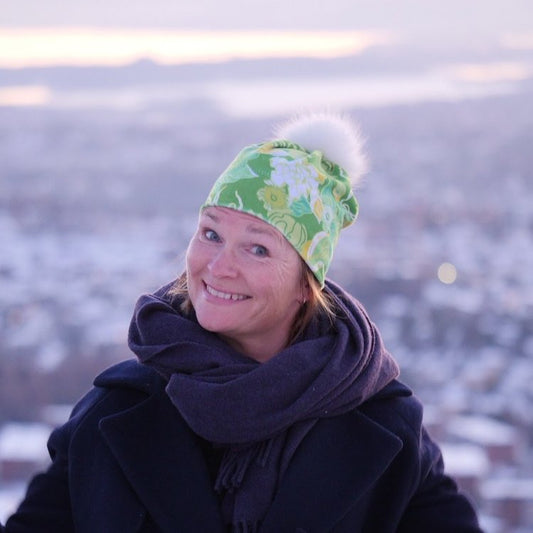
[0,361,480,533]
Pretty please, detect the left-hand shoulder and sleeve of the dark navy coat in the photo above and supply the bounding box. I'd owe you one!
[4,360,170,532]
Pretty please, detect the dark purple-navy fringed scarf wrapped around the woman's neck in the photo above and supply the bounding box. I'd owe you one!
[129,281,399,531]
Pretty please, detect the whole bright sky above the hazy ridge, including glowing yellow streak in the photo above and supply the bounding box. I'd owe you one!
[0,0,533,68]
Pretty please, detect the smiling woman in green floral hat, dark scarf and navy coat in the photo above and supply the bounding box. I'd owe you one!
[1,111,480,533]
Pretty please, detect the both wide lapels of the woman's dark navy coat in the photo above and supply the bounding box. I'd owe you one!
[100,384,402,533]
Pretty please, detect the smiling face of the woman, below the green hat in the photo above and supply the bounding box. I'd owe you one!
[187,207,307,361]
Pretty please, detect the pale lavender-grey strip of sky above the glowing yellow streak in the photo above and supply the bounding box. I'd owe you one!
[4,0,533,38]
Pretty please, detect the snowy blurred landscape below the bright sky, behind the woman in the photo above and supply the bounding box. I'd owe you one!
[0,38,533,533]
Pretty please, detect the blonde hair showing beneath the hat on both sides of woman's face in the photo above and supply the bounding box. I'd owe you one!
[168,259,335,346]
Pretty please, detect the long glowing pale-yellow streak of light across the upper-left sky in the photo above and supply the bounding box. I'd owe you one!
[0,28,388,68]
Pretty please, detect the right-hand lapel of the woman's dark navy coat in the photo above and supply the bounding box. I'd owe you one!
[261,411,402,533]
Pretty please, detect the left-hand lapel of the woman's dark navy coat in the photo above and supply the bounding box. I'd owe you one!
[100,389,224,533]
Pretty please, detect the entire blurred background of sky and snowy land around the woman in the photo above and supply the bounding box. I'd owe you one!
[0,0,533,533]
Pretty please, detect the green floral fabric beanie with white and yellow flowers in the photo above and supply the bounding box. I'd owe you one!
[202,116,362,286]
